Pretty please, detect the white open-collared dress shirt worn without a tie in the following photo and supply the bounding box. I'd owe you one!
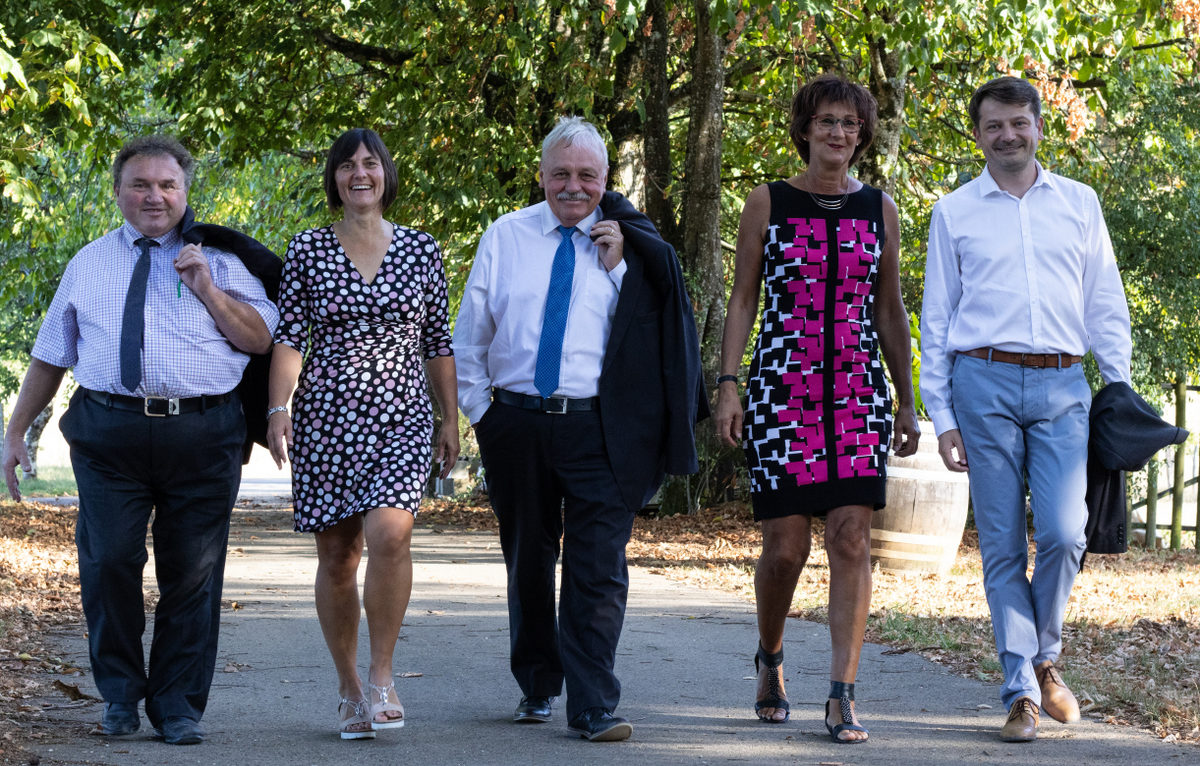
[920,164,1133,435]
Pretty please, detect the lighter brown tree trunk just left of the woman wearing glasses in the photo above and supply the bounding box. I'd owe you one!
[680,0,725,379]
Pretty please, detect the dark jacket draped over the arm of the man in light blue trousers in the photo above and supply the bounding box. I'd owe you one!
[1086,382,1188,553]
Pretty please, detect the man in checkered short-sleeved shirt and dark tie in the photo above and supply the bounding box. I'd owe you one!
[2,136,278,744]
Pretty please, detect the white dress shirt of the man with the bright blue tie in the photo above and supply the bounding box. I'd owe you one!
[454,202,628,424]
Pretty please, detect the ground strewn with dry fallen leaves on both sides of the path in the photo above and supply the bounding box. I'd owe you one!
[0,497,1200,764]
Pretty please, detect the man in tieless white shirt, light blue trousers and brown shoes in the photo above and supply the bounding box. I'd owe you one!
[920,77,1132,742]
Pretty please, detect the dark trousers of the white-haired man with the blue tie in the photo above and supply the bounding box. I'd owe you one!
[475,402,636,718]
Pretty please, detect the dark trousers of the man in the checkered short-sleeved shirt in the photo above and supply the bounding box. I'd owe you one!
[61,391,246,726]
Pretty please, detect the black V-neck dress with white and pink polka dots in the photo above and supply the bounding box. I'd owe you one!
[275,226,452,532]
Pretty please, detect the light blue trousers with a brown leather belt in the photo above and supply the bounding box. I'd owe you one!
[952,354,1092,708]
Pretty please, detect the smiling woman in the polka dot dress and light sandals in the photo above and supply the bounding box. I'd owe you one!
[268,130,458,740]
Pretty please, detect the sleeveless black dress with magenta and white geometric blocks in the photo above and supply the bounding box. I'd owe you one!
[743,181,892,520]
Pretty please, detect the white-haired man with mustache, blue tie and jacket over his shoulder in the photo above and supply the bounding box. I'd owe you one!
[454,118,707,741]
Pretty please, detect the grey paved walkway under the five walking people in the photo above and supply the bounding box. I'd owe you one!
[21,453,1200,766]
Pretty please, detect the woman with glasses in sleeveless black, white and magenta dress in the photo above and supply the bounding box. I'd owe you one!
[715,76,919,743]
